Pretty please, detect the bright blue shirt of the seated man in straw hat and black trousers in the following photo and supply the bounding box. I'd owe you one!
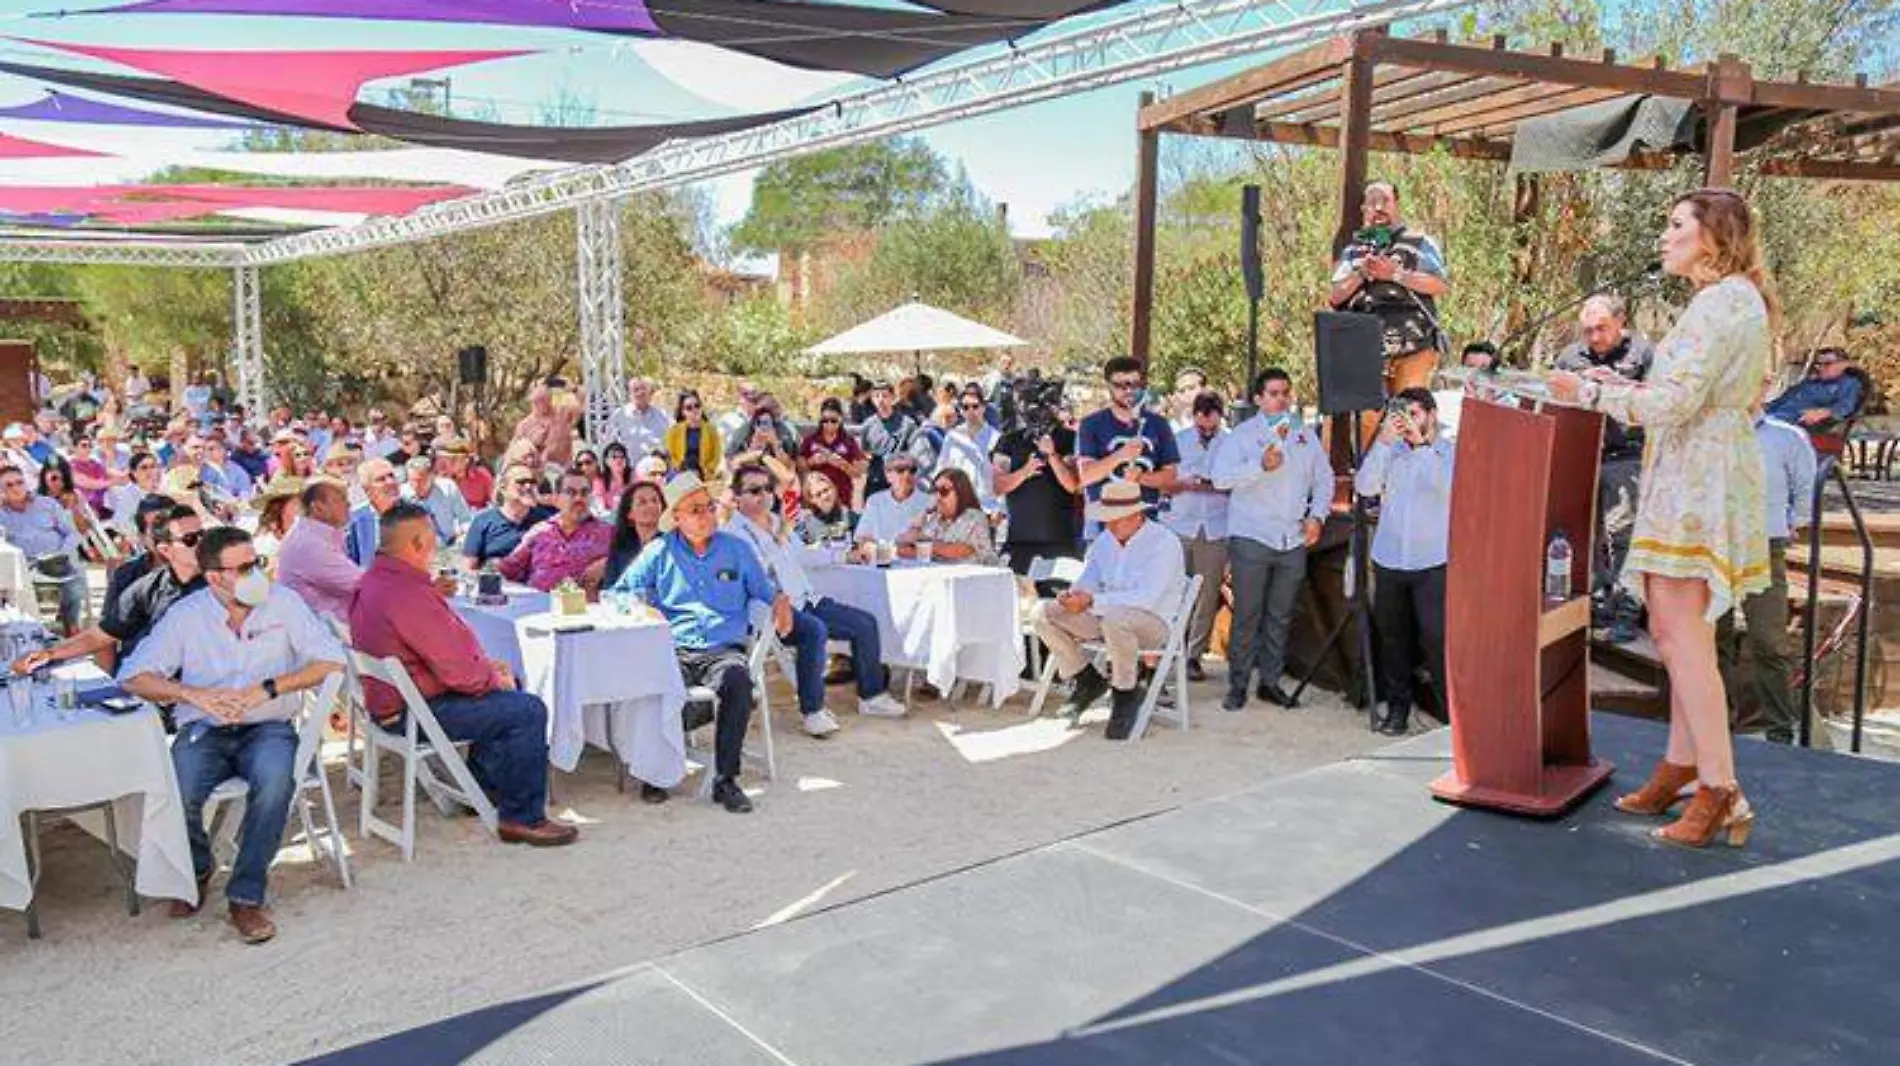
[612,530,779,652]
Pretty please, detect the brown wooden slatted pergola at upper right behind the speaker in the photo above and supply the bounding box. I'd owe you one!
[1131,27,1900,361]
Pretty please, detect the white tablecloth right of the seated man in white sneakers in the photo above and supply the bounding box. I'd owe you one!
[808,555,1022,703]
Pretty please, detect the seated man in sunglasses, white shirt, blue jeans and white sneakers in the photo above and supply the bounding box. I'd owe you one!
[726,464,904,737]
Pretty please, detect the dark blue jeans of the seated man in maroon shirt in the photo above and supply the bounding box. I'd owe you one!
[414,688,547,825]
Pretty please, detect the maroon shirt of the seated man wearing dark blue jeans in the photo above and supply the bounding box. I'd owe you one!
[349,551,502,718]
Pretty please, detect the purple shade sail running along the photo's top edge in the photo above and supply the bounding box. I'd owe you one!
[61,0,659,34]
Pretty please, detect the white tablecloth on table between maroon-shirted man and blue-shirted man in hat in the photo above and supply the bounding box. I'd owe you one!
[456,589,686,789]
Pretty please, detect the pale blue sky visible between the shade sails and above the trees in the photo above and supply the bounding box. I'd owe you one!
[0,0,1436,236]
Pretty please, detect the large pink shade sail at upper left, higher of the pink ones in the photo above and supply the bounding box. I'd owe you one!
[15,38,532,131]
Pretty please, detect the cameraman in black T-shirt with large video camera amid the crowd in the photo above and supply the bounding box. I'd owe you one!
[990,378,1081,574]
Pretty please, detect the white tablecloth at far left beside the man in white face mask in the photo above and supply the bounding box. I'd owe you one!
[0,665,198,910]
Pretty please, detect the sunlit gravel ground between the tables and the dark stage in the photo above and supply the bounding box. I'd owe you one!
[0,669,1379,1064]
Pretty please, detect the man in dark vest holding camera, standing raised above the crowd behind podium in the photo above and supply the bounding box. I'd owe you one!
[1330,181,1452,395]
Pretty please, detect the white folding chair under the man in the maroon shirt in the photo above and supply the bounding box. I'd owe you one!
[350,650,500,863]
